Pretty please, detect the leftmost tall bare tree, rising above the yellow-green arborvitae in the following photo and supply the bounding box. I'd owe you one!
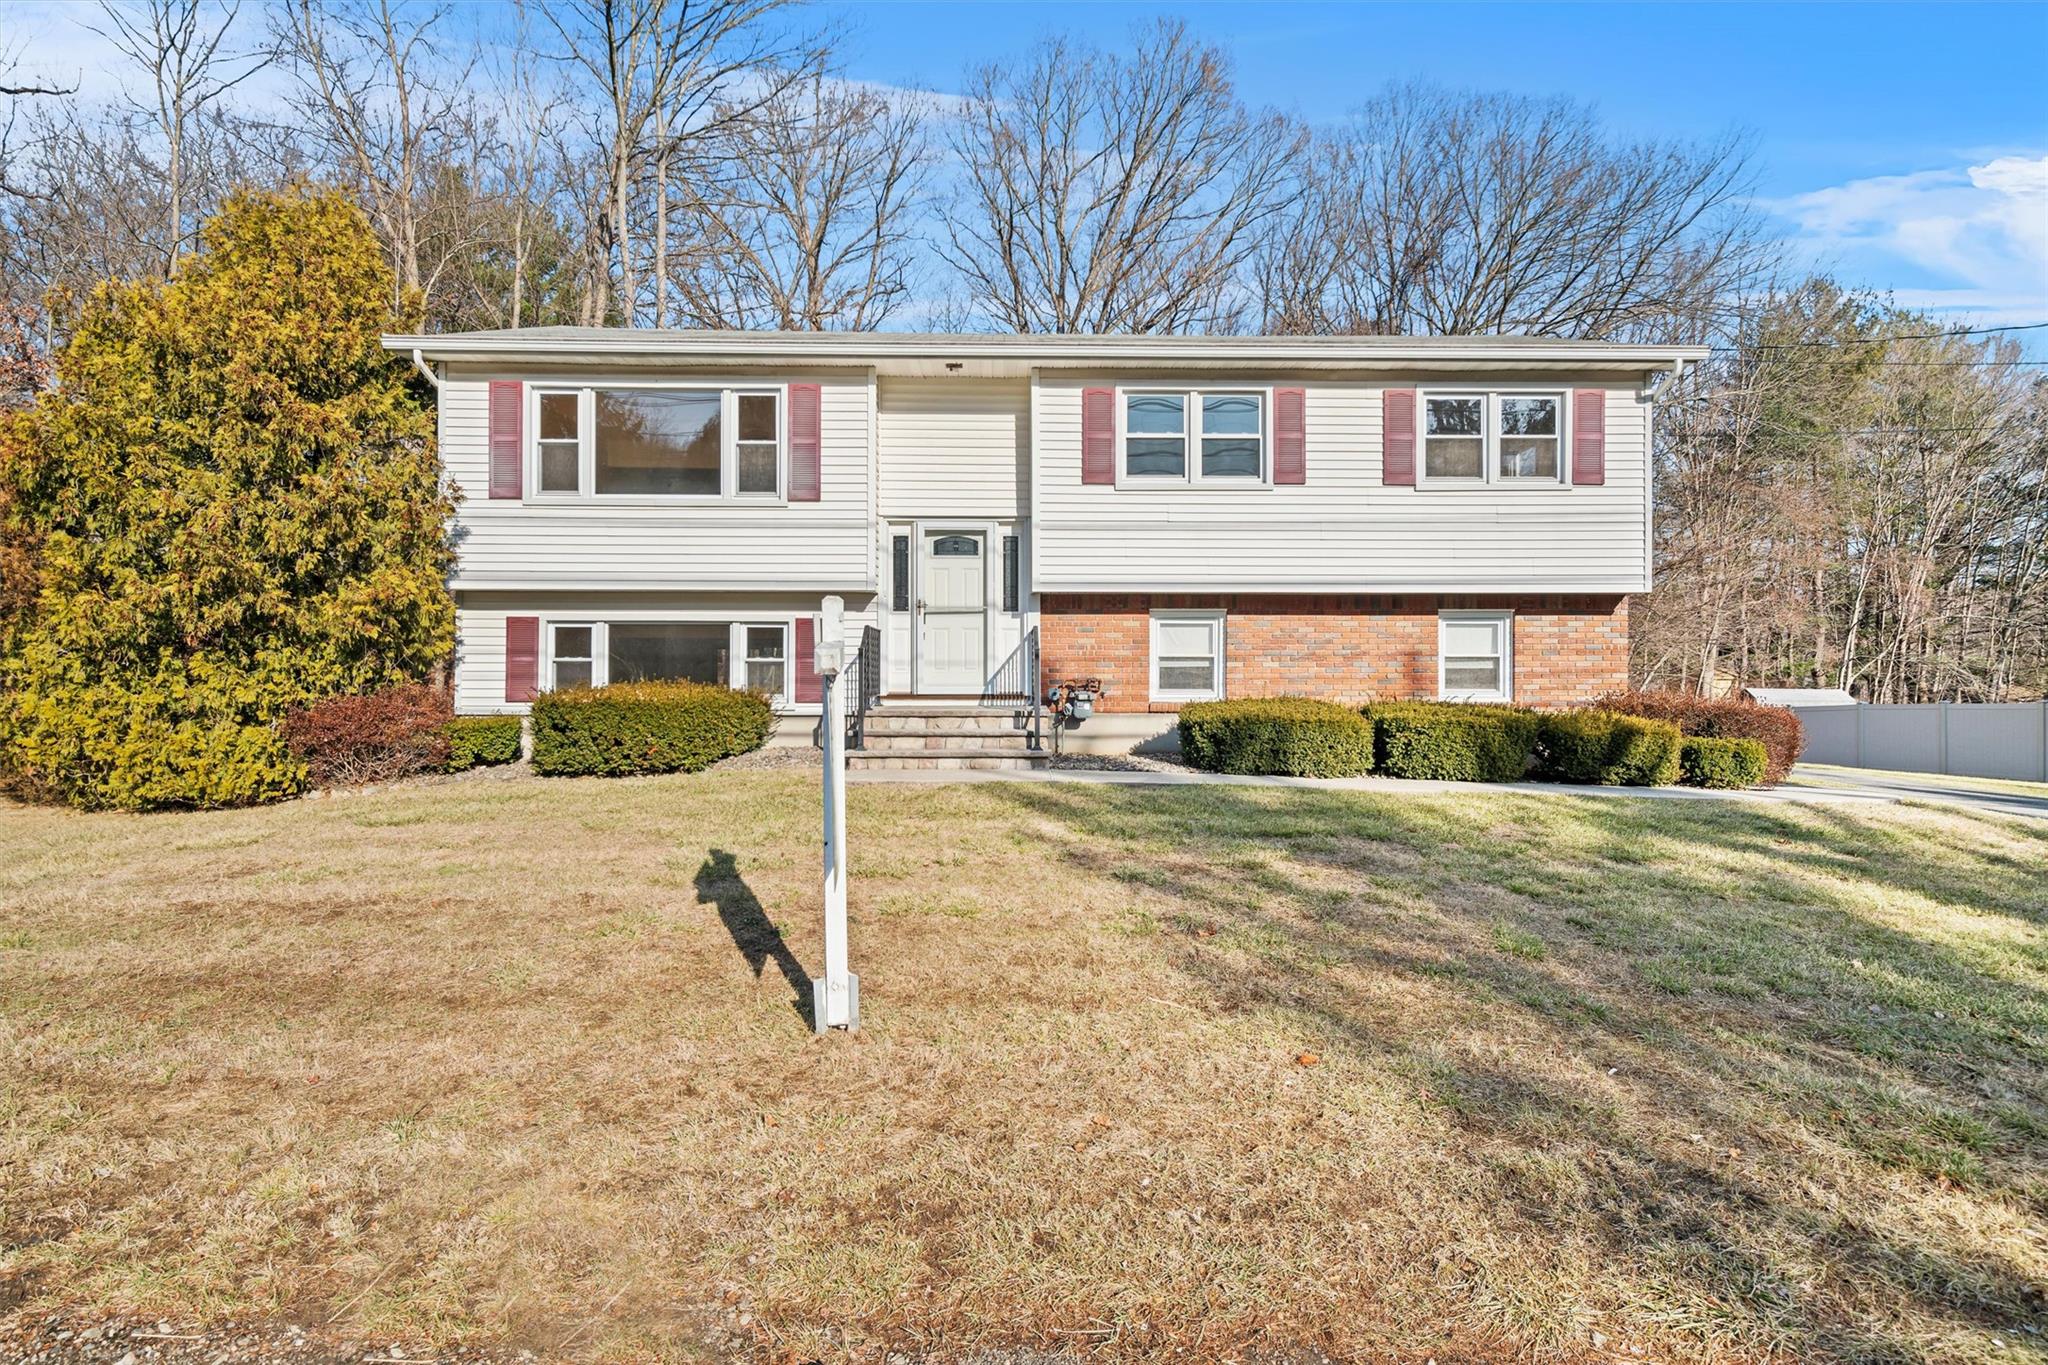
[94,0,268,274]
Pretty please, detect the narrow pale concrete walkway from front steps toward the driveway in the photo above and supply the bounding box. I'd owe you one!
[846,767,2048,819]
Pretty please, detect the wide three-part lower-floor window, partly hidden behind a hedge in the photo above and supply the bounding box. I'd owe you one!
[547,620,788,698]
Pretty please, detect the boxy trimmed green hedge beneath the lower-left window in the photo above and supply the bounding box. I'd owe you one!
[532,681,774,778]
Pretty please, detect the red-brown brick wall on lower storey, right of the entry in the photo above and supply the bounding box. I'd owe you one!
[1038,593,1628,712]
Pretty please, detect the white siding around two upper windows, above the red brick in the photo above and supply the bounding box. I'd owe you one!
[1032,372,1649,593]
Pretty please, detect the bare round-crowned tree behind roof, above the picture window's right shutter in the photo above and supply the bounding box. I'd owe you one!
[657,76,928,332]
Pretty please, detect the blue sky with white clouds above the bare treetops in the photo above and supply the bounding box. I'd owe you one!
[16,0,2048,323]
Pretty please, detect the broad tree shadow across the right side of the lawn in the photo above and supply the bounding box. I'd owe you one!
[1001,784,2048,1359]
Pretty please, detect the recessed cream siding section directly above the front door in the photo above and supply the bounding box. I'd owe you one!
[877,379,1030,520]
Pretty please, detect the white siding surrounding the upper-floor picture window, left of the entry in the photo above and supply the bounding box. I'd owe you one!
[440,366,874,593]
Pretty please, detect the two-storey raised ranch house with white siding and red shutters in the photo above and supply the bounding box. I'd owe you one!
[385,327,1704,763]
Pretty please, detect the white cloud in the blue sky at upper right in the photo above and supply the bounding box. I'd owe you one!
[1765,156,2048,323]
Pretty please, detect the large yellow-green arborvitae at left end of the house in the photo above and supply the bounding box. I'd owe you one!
[0,190,455,810]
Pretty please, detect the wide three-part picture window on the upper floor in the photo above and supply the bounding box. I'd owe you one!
[530,385,788,501]
